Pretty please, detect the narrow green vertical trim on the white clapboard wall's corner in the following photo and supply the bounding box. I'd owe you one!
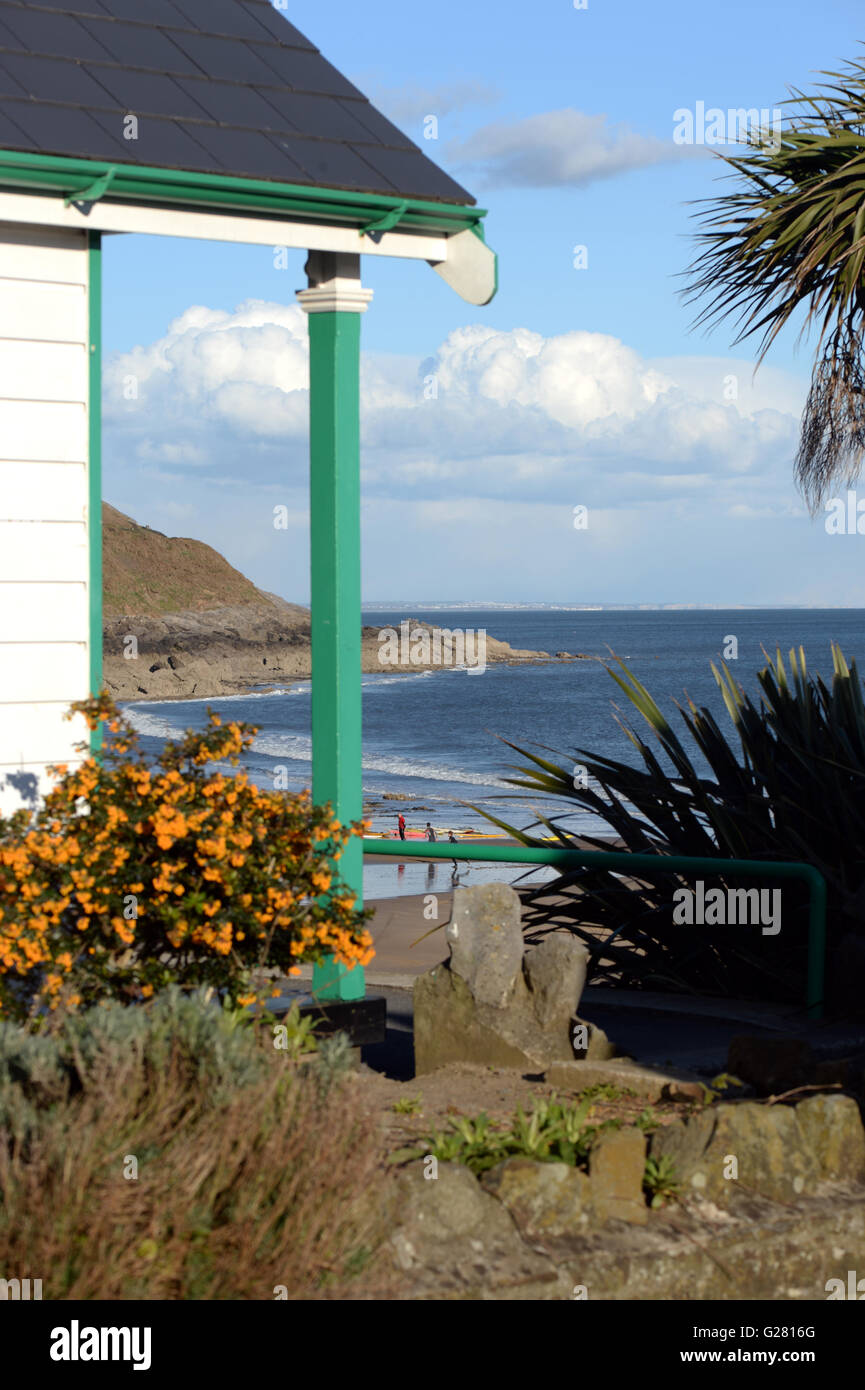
[88,232,102,753]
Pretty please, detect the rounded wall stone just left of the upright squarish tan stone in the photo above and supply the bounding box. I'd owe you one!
[481,1158,592,1237]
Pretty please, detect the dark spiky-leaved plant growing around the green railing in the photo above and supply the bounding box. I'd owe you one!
[487,644,865,1004]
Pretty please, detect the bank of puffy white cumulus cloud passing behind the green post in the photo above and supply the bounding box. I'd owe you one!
[106,302,802,525]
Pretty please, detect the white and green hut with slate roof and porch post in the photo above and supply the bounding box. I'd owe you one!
[0,0,496,999]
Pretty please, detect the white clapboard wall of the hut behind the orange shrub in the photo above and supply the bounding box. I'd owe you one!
[0,222,91,815]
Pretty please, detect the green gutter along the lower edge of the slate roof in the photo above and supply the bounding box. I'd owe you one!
[0,150,487,236]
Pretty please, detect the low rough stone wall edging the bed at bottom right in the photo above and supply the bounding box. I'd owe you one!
[387,1094,865,1302]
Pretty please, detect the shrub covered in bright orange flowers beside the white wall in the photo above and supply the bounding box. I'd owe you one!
[0,694,373,1020]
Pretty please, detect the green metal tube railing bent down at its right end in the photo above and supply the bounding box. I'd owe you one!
[363,838,826,1019]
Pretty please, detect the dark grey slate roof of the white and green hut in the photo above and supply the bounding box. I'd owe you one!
[0,0,474,204]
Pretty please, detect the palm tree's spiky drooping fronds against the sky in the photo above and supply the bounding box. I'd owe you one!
[686,61,865,512]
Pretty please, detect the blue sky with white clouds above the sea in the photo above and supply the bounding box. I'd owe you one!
[104,0,865,606]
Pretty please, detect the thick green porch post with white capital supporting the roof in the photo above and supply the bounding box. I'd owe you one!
[298,252,373,999]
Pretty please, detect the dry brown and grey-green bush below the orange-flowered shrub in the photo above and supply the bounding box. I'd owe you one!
[0,990,387,1300]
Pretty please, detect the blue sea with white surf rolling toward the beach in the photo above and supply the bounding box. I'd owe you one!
[125,606,865,901]
